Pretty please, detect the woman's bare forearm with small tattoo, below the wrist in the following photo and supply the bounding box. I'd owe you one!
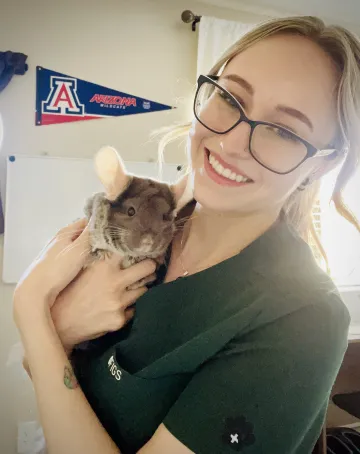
[21,310,119,454]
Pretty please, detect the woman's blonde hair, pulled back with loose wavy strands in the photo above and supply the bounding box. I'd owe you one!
[159,16,360,262]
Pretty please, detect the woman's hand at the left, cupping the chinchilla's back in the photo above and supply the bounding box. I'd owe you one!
[14,219,90,317]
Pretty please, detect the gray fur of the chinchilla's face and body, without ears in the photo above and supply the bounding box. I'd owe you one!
[84,177,176,288]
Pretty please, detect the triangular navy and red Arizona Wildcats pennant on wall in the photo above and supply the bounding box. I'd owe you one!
[36,66,173,126]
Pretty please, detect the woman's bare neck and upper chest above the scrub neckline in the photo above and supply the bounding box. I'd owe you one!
[178,203,278,273]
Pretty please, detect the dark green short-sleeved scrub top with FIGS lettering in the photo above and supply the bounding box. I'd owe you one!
[72,210,350,454]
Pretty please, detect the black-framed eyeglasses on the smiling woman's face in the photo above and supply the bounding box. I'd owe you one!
[194,75,336,175]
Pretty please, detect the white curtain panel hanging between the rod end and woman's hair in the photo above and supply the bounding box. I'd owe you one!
[197,16,255,76]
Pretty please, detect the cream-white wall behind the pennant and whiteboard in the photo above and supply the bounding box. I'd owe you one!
[0,0,264,454]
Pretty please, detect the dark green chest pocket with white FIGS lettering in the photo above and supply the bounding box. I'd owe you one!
[81,348,192,454]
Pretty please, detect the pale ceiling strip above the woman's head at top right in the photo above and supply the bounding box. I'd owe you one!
[201,0,360,30]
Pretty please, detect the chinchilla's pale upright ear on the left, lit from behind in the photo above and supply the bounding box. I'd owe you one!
[95,146,130,200]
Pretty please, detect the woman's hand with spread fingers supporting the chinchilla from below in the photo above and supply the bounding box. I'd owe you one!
[51,256,156,353]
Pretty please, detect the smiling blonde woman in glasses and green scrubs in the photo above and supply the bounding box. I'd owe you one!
[14,17,360,454]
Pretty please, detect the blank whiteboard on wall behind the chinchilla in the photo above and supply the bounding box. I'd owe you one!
[3,155,179,284]
